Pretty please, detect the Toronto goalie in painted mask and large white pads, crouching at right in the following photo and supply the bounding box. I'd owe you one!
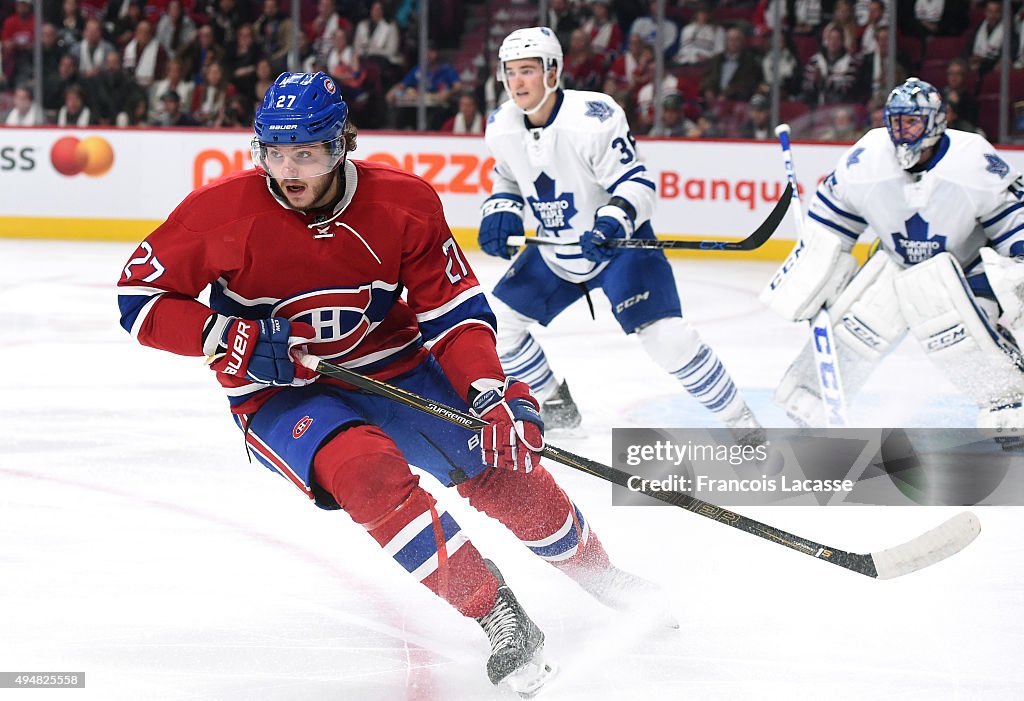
[762,78,1024,430]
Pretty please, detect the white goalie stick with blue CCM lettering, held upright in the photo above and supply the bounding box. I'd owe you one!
[775,124,848,428]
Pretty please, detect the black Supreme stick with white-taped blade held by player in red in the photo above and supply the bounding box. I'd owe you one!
[301,355,981,579]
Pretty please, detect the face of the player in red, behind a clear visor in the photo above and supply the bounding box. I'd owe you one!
[264,143,338,210]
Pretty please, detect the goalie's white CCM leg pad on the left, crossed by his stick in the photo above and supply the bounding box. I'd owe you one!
[774,251,906,427]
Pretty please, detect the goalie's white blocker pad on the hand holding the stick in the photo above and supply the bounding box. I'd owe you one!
[760,219,857,321]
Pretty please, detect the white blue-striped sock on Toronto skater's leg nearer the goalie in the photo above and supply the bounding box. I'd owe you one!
[637,316,746,425]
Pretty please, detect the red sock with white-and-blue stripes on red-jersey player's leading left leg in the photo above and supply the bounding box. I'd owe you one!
[313,426,498,617]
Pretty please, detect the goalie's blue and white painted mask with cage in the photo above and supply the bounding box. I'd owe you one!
[882,78,946,170]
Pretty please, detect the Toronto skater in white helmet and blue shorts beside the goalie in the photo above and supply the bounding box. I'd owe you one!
[479,27,760,429]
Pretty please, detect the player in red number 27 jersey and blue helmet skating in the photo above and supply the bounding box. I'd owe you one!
[119,73,667,693]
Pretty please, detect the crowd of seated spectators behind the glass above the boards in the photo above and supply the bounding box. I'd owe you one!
[0,0,1024,141]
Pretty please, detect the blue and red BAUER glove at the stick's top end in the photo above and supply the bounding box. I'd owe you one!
[210,316,316,386]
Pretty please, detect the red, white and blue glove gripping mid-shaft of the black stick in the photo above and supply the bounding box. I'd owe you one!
[472,378,544,472]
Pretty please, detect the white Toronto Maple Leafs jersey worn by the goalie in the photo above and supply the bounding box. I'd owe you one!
[807,129,1024,275]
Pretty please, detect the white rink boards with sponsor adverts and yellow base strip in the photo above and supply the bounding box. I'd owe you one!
[0,128,1024,259]
